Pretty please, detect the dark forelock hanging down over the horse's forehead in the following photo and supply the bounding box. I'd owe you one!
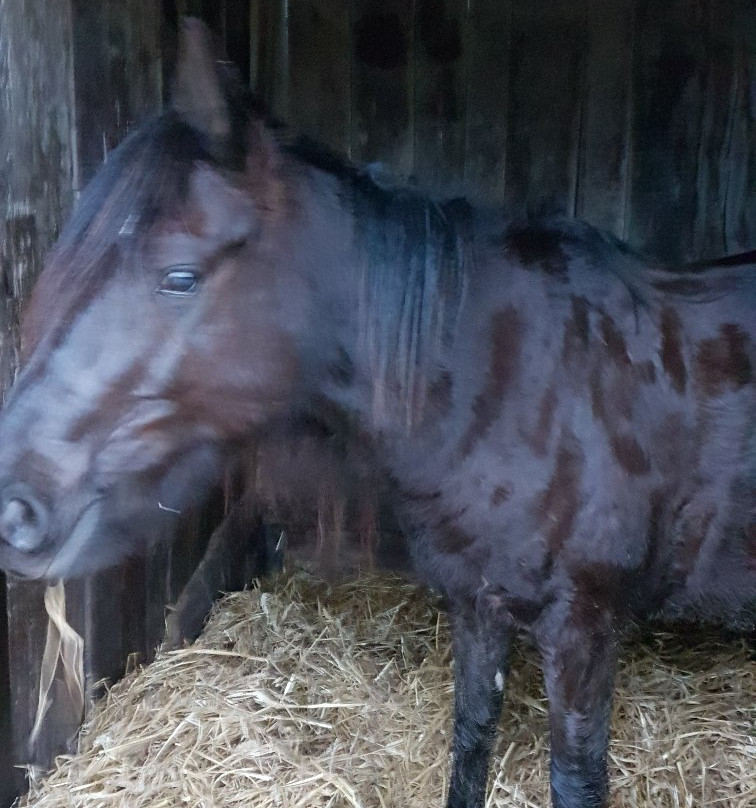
[22,112,213,356]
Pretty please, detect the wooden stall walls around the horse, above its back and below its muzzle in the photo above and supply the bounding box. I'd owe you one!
[0,0,756,804]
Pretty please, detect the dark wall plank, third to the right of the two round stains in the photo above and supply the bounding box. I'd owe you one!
[575,0,634,238]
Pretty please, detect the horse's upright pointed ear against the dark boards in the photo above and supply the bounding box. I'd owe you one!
[172,17,232,159]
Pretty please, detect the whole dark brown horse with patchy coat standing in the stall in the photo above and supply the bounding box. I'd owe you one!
[0,24,756,808]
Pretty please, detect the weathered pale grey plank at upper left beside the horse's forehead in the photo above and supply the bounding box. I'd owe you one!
[0,0,75,288]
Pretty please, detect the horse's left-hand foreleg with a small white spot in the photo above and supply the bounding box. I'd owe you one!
[447,599,511,808]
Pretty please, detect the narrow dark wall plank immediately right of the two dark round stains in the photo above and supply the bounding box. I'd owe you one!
[464,0,513,204]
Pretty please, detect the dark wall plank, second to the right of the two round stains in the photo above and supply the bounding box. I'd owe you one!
[505,0,586,215]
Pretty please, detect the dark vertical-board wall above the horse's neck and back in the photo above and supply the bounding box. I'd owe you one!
[251,0,756,261]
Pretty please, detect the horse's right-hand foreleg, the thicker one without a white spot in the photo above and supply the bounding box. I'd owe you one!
[538,600,617,808]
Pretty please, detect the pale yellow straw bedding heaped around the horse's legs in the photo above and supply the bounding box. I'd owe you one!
[21,572,756,808]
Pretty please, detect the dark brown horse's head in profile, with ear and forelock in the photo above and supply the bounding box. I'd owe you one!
[0,24,301,579]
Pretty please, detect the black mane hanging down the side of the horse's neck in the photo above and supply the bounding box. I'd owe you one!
[281,138,473,429]
